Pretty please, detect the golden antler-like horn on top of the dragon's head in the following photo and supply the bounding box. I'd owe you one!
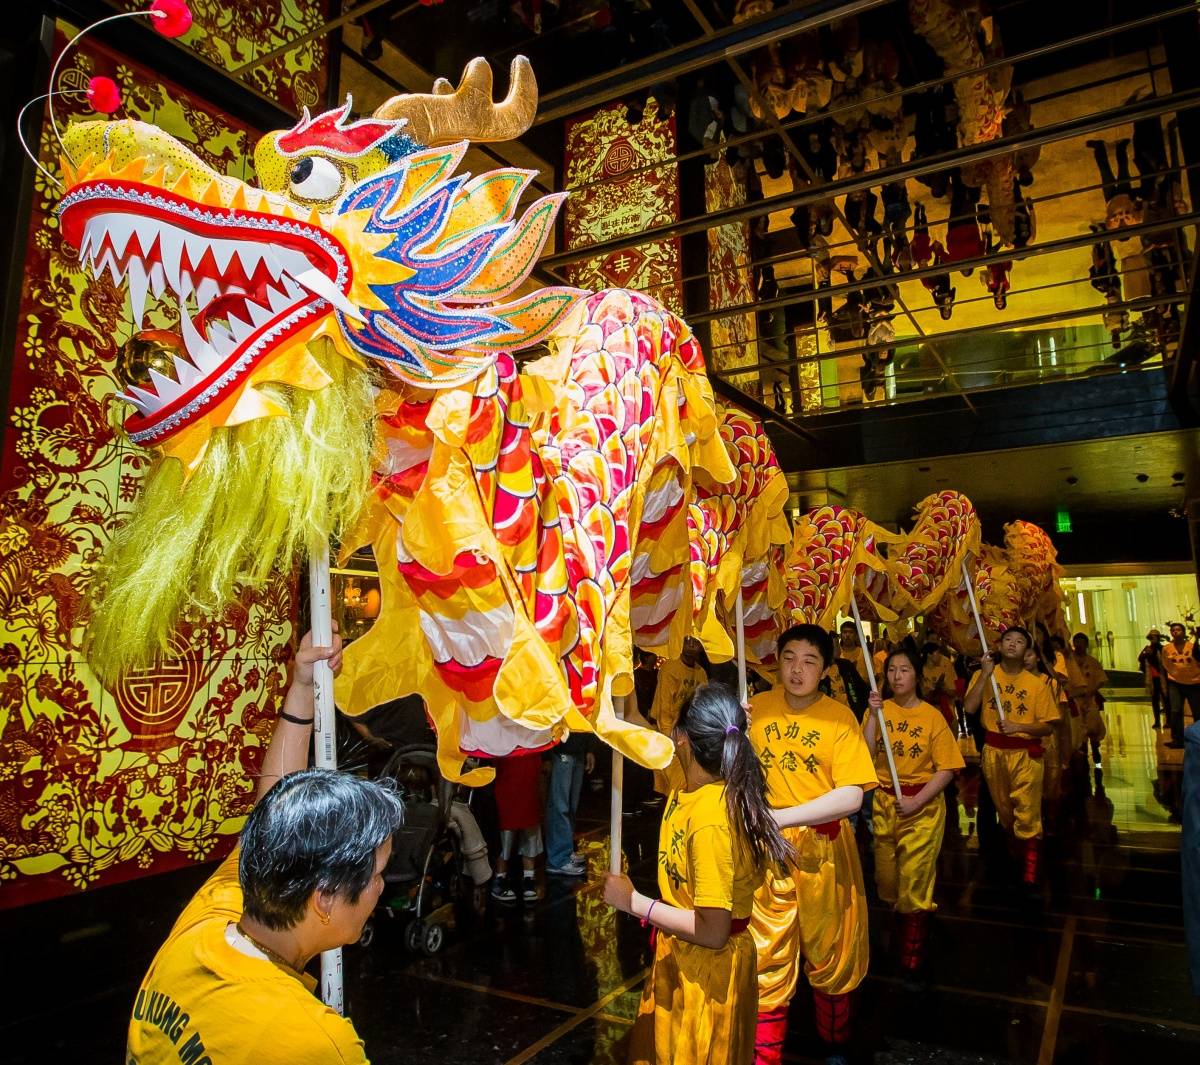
[374,55,538,148]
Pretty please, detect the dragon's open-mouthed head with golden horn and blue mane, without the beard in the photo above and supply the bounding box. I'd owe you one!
[59,56,574,468]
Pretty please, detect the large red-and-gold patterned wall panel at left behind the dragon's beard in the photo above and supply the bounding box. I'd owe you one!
[0,28,295,907]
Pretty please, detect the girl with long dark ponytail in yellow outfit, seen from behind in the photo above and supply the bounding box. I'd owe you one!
[605,684,792,1065]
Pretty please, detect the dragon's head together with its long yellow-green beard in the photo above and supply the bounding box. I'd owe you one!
[59,56,581,674]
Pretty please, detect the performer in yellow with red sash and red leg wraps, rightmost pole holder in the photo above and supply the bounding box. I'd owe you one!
[962,625,1058,886]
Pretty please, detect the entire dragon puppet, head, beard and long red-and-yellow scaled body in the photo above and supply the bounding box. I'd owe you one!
[59,58,1054,783]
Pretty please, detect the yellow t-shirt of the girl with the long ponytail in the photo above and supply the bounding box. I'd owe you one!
[659,782,762,920]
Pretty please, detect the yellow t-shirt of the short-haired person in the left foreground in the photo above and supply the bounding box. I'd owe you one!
[126,850,367,1065]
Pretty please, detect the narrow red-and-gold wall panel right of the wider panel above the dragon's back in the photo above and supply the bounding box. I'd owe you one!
[704,156,761,396]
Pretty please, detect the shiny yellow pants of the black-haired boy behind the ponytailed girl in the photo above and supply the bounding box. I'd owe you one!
[750,820,868,1012]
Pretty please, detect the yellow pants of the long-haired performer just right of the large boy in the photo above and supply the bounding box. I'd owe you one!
[871,788,946,914]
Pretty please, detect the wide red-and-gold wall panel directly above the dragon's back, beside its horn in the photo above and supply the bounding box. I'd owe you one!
[563,101,683,314]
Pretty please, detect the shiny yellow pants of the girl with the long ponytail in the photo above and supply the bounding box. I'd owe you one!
[629,931,758,1065]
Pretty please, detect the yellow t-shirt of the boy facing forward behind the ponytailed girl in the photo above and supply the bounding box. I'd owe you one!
[750,686,877,808]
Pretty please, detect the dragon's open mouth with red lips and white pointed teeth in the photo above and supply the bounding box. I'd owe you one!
[59,180,359,444]
